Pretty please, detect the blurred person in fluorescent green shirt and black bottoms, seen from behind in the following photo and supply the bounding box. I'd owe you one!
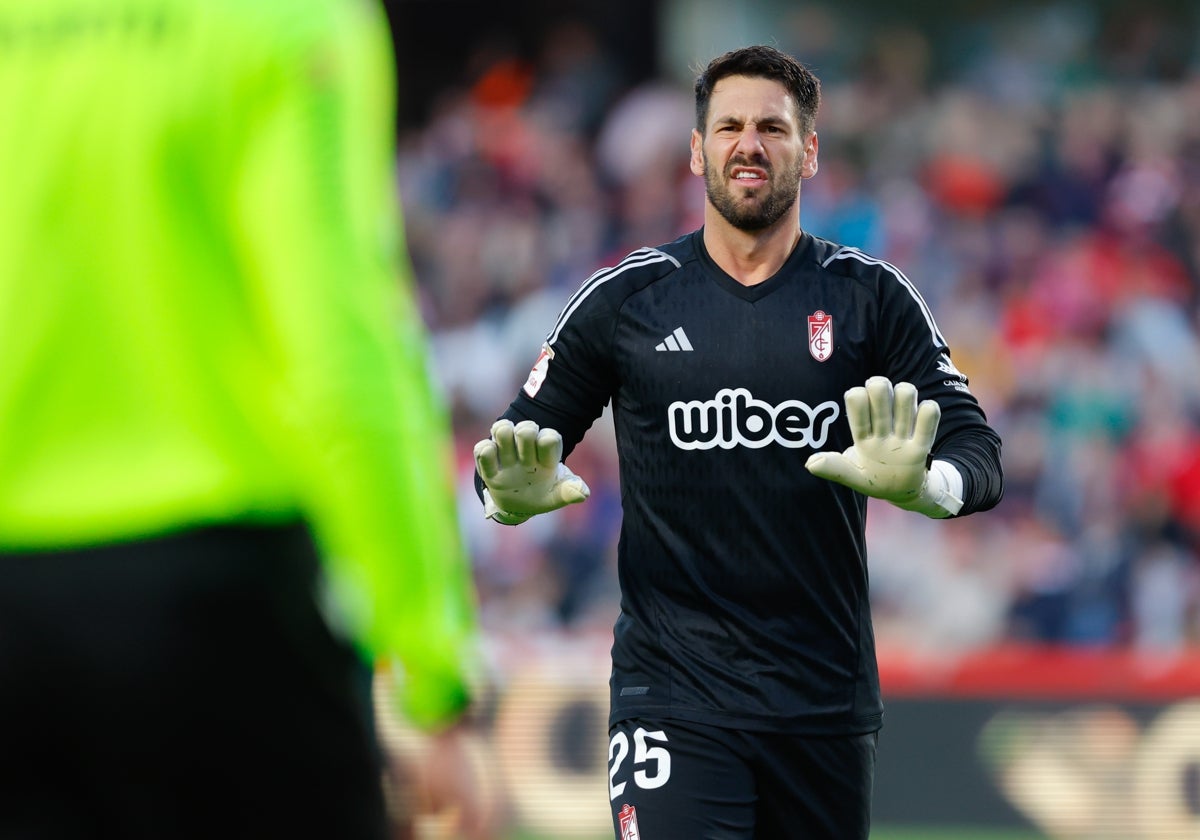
[0,0,489,839]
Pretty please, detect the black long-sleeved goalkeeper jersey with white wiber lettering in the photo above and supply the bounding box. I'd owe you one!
[487,230,1002,733]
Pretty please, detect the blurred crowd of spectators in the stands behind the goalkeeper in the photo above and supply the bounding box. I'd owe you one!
[398,1,1200,652]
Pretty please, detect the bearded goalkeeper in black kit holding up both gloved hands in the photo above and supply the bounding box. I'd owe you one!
[475,47,1002,840]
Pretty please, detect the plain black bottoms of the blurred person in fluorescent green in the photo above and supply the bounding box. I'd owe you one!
[0,527,386,840]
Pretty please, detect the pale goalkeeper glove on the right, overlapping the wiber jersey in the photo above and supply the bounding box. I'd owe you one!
[804,377,962,518]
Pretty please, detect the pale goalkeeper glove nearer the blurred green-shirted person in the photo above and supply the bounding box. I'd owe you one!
[475,420,590,524]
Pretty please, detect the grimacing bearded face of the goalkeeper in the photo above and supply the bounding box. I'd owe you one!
[691,76,817,232]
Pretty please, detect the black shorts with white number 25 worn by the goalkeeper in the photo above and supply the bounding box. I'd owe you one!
[608,718,877,840]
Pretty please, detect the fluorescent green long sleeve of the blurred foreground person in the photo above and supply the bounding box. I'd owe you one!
[229,4,474,725]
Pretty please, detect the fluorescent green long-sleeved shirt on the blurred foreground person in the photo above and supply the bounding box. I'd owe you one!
[0,0,473,722]
